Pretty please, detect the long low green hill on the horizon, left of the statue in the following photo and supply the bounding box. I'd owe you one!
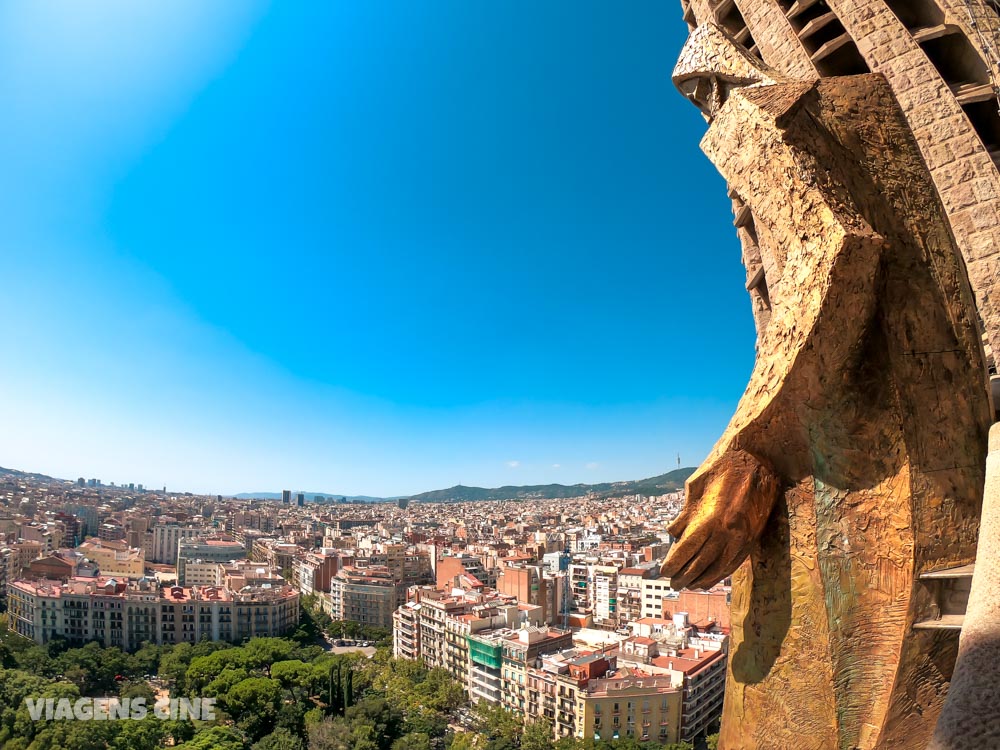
[411,466,696,503]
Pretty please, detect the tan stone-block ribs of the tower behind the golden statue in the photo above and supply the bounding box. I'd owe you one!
[691,0,1000,374]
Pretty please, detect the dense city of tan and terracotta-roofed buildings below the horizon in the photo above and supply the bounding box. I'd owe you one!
[0,470,730,748]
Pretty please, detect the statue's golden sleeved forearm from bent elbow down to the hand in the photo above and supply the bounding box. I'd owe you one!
[662,181,885,589]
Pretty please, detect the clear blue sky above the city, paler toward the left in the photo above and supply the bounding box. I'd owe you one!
[0,0,753,495]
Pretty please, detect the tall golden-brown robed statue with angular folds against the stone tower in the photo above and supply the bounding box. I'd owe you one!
[663,23,991,750]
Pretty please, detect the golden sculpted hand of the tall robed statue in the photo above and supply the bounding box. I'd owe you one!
[660,450,781,589]
